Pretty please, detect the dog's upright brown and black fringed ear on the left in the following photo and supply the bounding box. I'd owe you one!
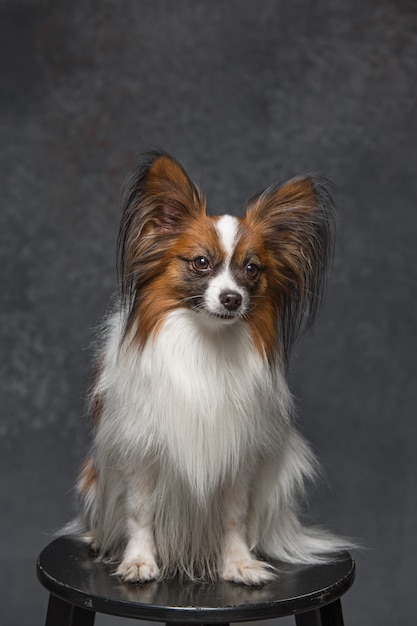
[118,152,206,297]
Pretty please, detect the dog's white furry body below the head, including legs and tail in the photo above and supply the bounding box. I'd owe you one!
[75,309,348,584]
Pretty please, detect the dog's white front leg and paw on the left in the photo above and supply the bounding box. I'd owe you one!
[116,470,160,582]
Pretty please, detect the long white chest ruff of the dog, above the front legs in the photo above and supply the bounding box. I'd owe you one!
[96,309,291,495]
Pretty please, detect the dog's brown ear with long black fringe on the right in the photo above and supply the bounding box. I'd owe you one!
[245,176,334,365]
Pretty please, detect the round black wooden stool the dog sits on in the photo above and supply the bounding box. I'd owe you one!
[37,537,355,626]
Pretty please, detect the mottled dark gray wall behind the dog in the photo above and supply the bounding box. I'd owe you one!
[0,0,417,626]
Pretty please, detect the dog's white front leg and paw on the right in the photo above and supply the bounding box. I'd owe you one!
[221,472,275,585]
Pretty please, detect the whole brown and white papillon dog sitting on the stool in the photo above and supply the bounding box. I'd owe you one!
[76,152,345,585]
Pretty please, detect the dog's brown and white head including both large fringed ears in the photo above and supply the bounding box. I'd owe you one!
[119,153,332,358]
